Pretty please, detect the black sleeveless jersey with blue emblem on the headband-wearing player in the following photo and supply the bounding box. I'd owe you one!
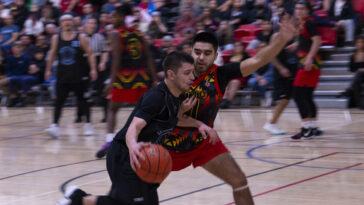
[57,34,84,83]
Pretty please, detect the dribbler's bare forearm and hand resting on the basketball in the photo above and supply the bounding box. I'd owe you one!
[125,117,150,170]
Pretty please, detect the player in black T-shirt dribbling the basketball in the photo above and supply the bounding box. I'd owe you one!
[59,51,209,205]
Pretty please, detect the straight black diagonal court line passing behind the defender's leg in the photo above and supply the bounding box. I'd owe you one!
[159,152,339,203]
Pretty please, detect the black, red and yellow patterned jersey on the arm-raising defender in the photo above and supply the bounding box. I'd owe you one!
[161,63,242,152]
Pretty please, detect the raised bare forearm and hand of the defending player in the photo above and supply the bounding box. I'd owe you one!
[240,17,296,77]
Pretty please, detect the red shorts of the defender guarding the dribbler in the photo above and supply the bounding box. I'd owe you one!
[168,137,229,171]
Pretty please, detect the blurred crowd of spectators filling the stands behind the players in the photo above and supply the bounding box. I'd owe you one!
[0,0,364,107]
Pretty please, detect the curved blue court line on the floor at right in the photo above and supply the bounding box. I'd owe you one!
[246,141,364,170]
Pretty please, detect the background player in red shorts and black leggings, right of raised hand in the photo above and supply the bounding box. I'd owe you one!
[291,0,322,140]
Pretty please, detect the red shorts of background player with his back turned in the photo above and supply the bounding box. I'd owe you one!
[111,88,149,103]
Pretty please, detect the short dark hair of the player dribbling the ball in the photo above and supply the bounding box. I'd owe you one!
[162,51,195,77]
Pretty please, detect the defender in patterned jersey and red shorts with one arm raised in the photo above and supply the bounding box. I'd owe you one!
[162,19,296,205]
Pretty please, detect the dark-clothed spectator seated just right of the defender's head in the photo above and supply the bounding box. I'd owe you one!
[216,20,234,50]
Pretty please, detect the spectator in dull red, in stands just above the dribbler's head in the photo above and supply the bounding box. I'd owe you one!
[174,7,196,38]
